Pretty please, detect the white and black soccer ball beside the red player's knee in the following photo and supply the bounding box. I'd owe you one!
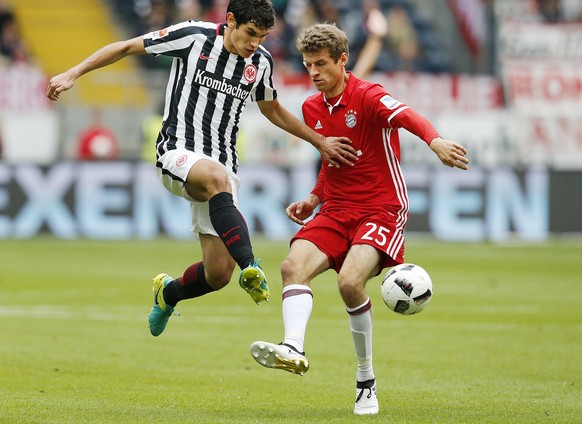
[382,264,433,315]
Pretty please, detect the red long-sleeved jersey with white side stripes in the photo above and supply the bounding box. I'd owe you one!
[302,73,438,219]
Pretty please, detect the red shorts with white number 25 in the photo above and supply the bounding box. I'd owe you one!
[291,210,406,273]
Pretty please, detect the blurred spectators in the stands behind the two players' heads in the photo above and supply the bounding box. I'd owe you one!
[112,0,449,73]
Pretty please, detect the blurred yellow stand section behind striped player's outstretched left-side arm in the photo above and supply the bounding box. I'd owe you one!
[13,0,147,106]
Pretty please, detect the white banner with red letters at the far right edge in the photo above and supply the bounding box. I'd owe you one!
[500,23,582,169]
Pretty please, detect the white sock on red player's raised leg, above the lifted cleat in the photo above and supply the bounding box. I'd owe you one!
[282,284,313,352]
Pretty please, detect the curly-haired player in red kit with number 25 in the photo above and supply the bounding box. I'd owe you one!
[251,24,469,415]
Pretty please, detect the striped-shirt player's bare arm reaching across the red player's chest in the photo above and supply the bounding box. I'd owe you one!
[258,99,358,168]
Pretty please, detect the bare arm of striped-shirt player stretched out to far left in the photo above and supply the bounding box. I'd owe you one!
[46,36,145,101]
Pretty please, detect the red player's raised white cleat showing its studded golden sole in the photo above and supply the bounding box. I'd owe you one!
[251,342,309,375]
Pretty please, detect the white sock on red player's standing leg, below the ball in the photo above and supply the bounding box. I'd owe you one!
[346,298,375,381]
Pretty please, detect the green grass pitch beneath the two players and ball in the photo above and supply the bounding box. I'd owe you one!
[0,238,582,423]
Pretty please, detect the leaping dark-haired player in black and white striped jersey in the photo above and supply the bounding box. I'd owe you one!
[47,0,357,336]
